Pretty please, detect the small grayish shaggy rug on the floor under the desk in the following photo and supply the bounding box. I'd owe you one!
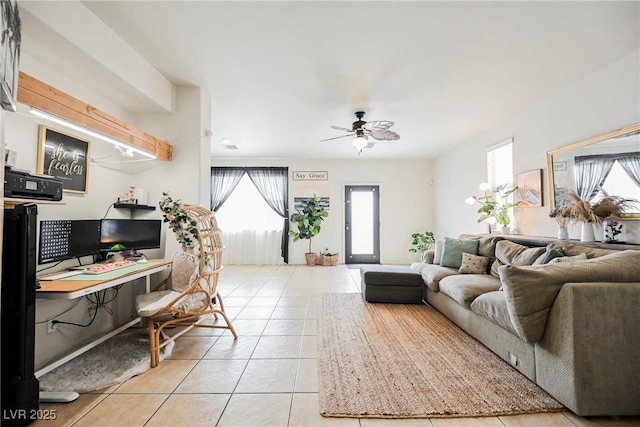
[39,328,174,393]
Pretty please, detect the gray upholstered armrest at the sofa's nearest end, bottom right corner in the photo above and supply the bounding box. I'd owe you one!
[536,282,640,416]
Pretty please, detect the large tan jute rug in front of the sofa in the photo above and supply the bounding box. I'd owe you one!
[318,293,562,418]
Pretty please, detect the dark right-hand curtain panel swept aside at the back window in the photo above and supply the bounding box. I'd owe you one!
[245,167,289,263]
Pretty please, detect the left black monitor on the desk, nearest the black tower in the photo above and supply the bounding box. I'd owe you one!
[38,219,100,264]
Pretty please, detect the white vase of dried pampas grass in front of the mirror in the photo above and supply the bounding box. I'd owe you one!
[556,190,638,242]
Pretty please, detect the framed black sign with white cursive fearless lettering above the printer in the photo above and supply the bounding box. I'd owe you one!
[36,125,90,194]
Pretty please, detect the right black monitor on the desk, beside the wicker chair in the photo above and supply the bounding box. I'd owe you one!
[100,219,162,251]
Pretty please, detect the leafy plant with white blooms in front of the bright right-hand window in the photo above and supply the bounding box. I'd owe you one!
[468,183,520,234]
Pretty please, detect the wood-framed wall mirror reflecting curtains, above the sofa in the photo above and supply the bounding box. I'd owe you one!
[547,123,640,219]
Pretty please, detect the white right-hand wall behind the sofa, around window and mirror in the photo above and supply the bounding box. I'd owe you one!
[434,51,640,243]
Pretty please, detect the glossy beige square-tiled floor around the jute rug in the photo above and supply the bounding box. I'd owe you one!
[33,265,640,427]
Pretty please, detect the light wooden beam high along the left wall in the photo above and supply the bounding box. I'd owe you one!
[18,72,173,160]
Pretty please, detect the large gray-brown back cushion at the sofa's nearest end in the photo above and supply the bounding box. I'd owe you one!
[499,250,640,343]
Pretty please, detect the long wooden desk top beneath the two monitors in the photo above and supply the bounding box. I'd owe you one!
[36,259,171,296]
